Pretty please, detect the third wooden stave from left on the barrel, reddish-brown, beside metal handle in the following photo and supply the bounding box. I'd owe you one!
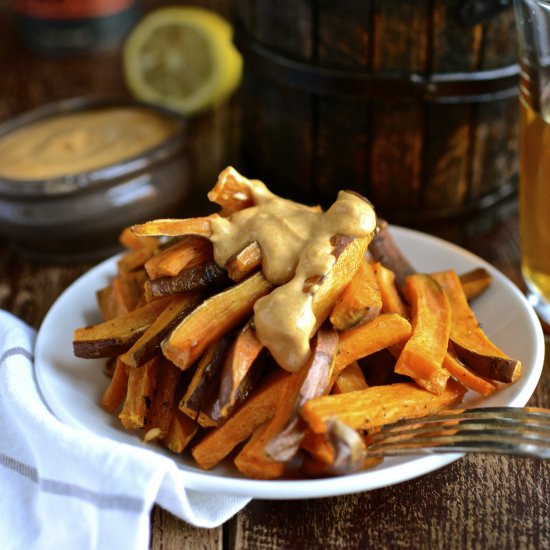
[370,0,431,218]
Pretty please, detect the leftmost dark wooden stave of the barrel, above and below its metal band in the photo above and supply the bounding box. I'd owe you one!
[237,0,314,203]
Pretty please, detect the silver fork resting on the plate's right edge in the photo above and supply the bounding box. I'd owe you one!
[367,407,550,459]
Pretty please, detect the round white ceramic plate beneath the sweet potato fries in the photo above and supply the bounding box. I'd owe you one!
[36,227,544,499]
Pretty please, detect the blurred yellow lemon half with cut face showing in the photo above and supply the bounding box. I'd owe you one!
[123,6,246,115]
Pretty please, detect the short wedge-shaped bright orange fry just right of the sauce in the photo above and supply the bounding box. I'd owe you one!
[330,256,382,330]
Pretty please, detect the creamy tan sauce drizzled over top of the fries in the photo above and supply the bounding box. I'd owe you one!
[211,169,376,372]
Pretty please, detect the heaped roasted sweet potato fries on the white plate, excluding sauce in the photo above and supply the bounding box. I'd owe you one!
[73,168,521,479]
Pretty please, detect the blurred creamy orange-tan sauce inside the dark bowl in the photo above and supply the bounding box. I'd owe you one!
[0,107,178,180]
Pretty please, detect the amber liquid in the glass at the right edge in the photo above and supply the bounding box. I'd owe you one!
[520,97,550,316]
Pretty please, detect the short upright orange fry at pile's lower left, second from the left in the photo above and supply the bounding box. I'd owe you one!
[118,355,158,430]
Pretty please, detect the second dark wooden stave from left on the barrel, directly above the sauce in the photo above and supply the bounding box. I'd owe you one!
[314,0,374,204]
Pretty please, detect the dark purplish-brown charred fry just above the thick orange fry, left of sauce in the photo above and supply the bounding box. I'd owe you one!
[145,261,229,298]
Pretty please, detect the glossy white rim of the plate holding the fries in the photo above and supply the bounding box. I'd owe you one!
[35,225,545,500]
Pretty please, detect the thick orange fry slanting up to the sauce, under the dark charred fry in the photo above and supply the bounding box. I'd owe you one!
[161,272,273,369]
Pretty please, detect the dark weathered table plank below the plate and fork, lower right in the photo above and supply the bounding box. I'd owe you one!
[230,455,550,550]
